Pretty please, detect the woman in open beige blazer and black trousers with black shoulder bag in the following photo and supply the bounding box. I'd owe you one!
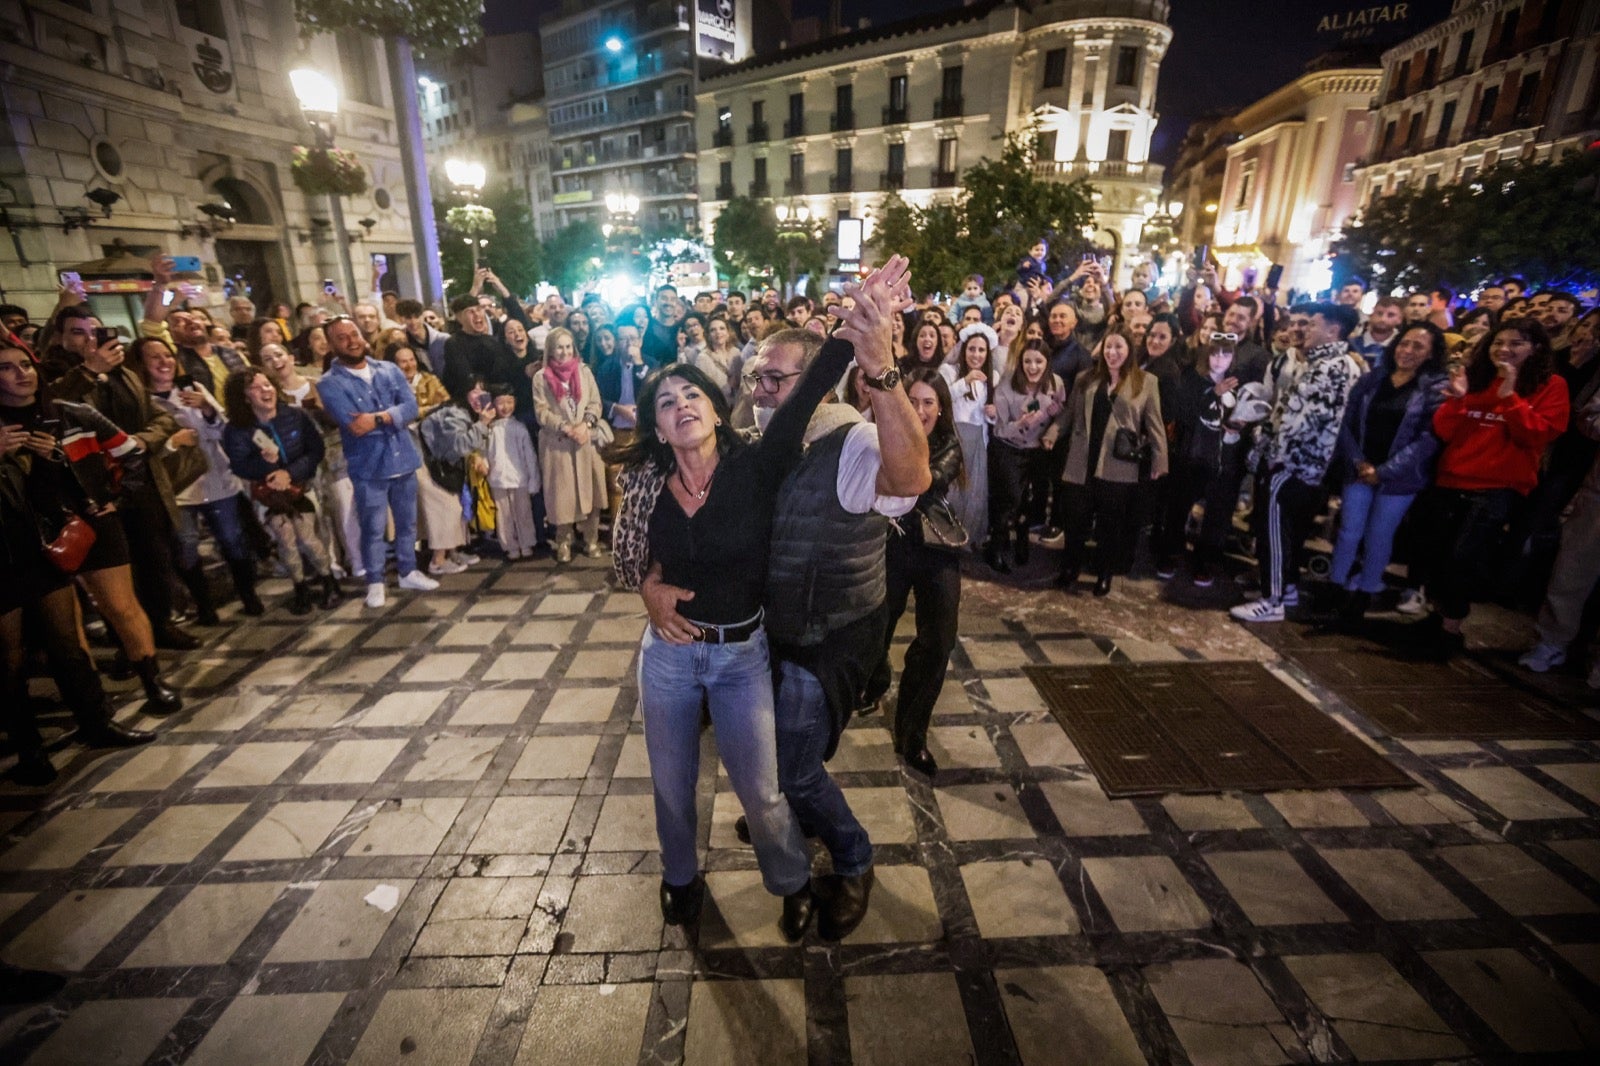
[1058,330,1166,595]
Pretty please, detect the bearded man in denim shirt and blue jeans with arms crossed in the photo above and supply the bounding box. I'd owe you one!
[317,317,438,607]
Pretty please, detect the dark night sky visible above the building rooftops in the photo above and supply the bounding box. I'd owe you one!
[483,0,1451,163]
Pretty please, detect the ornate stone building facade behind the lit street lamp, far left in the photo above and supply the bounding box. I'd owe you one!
[0,0,419,320]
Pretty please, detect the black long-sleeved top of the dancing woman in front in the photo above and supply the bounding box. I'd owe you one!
[650,339,854,626]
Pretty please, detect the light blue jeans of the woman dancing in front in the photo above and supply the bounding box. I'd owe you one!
[638,626,811,896]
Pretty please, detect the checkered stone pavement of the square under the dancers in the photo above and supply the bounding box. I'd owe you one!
[0,563,1600,1066]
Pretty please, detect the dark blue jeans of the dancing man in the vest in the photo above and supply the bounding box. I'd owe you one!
[778,663,872,877]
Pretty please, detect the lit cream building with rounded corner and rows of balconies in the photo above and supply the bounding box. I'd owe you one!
[696,0,1171,280]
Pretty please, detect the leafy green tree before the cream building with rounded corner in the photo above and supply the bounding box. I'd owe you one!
[872,131,1094,293]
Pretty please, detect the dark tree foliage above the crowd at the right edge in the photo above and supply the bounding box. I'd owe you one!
[1334,152,1600,291]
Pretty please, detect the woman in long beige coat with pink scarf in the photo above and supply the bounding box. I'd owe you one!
[533,328,606,563]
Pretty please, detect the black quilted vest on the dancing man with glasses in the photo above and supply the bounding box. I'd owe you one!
[766,426,888,647]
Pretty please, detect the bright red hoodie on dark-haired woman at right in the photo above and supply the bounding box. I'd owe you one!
[1434,375,1571,496]
